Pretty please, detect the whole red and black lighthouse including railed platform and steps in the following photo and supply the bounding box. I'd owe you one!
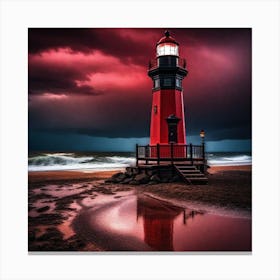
[135,31,208,184]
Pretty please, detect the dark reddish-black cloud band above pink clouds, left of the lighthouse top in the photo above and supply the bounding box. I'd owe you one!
[28,28,158,63]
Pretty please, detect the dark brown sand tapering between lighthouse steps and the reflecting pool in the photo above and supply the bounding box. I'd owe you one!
[140,166,252,211]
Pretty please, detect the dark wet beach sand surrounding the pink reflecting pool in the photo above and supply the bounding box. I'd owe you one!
[28,166,251,251]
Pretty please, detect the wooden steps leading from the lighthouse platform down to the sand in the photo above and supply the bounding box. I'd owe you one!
[174,164,208,185]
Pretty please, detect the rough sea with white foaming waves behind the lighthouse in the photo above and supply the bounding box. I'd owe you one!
[28,152,252,171]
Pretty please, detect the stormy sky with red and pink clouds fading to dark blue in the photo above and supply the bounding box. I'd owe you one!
[28,28,251,151]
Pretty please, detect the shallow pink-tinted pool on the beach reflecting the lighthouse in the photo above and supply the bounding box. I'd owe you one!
[73,195,251,251]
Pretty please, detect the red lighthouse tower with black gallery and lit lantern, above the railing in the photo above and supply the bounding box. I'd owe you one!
[148,31,188,150]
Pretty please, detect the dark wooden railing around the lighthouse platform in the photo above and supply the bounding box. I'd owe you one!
[136,143,205,166]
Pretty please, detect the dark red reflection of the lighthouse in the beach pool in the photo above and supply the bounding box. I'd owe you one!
[137,196,184,251]
